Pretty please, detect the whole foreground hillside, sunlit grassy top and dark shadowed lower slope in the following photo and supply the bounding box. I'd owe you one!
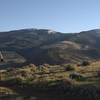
[0,62,100,100]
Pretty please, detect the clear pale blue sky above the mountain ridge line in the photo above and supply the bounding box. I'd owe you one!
[0,0,100,33]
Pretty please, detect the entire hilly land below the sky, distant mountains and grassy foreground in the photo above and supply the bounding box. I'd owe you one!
[0,29,100,100]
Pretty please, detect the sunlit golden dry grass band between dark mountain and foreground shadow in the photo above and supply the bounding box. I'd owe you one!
[0,62,100,84]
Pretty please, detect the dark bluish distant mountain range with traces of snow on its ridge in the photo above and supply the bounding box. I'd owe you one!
[0,29,100,65]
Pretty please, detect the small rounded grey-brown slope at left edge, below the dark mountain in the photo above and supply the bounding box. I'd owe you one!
[0,51,26,69]
